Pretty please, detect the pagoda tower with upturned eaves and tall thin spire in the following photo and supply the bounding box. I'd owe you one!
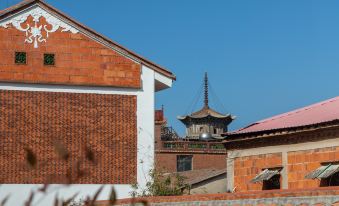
[177,72,235,141]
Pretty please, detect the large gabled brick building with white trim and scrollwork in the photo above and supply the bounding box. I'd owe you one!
[0,0,175,204]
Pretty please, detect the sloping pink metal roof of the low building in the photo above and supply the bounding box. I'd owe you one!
[229,96,339,134]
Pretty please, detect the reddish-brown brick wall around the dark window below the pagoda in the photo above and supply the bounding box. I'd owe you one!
[155,152,226,172]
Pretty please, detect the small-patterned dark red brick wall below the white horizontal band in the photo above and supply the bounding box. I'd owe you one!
[0,91,137,184]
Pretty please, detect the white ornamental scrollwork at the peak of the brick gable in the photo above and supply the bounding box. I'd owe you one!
[0,7,79,48]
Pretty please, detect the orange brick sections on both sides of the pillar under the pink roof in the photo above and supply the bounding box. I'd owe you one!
[234,147,339,192]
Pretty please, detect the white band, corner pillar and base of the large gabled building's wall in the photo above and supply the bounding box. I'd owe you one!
[0,66,163,206]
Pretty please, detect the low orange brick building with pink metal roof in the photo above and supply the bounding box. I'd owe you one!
[224,97,339,192]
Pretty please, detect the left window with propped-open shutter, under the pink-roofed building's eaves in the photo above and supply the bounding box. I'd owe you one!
[251,168,282,190]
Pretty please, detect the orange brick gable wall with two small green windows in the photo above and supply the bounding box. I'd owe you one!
[0,17,141,88]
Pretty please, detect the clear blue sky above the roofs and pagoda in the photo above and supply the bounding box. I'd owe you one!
[0,0,339,134]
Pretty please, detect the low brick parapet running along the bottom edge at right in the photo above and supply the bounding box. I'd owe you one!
[97,187,339,206]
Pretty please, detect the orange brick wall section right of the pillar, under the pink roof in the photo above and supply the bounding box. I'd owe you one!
[288,147,339,189]
